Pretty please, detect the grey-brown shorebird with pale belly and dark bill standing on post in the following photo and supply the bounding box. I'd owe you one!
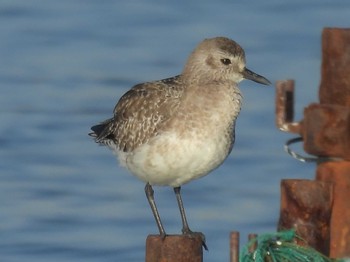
[90,37,271,247]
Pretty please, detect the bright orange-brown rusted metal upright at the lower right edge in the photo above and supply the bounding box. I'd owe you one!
[316,161,350,258]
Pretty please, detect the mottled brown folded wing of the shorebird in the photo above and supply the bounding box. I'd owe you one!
[95,77,183,152]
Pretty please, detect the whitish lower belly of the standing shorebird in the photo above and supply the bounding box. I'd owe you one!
[116,132,233,187]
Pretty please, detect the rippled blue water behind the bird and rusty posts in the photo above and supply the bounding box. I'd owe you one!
[0,0,350,262]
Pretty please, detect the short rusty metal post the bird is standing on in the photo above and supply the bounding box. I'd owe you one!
[145,234,203,262]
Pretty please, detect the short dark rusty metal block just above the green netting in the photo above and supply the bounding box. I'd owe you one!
[278,179,333,254]
